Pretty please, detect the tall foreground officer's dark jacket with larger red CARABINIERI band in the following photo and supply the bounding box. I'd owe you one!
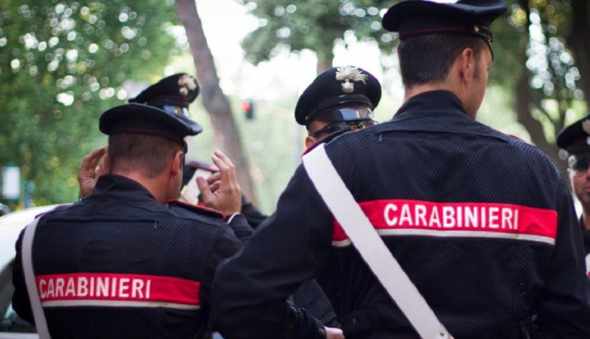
[212,91,590,339]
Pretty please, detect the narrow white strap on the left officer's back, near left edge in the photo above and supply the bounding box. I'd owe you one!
[21,218,51,339]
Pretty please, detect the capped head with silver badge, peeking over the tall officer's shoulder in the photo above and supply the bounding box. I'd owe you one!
[295,65,381,150]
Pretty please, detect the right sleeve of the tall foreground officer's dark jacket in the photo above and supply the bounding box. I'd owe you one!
[538,185,590,339]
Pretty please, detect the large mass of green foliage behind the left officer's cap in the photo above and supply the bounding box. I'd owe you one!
[0,0,176,204]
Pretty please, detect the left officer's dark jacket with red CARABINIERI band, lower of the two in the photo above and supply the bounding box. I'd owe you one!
[13,176,251,339]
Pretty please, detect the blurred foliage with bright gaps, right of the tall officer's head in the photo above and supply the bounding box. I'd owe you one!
[493,0,590,169]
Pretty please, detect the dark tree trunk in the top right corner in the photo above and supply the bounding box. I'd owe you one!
[567,0,590,108]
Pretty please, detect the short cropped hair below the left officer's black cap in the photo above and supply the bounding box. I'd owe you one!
[108,133,181,178]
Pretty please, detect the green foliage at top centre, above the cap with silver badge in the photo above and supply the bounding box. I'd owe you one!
[241,0,393,64]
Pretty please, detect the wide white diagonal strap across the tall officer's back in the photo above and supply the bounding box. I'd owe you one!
[303,144,452,339]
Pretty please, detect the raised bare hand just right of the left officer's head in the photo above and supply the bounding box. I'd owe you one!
[197,151,242,216]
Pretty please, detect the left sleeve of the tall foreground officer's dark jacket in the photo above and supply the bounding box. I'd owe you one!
[212,166,332,339]
